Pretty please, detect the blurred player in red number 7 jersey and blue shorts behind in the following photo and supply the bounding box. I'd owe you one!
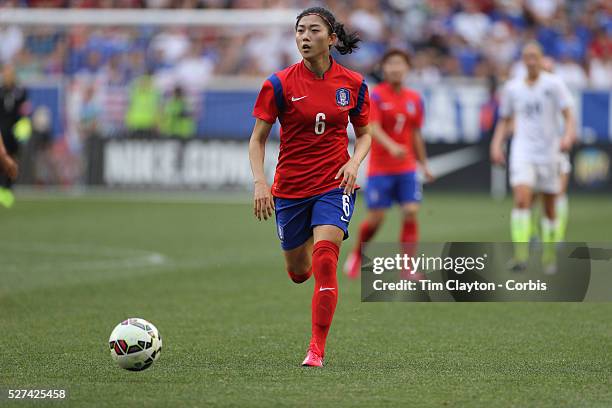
[344,49,433,278]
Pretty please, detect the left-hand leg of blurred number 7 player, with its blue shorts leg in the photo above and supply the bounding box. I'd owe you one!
[343,175,393,278]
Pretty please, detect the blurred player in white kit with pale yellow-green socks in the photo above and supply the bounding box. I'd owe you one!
[491,43,575,272]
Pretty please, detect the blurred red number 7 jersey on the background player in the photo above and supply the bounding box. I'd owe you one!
[368,82,424,176]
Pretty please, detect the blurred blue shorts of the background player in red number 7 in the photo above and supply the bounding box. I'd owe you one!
[366,171,423,208]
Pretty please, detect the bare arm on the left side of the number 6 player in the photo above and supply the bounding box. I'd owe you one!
[249,119,274,221]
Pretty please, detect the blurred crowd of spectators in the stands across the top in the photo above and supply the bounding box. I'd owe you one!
[0,0,612,90]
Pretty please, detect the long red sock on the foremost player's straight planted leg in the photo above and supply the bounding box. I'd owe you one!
[310,241,340,355]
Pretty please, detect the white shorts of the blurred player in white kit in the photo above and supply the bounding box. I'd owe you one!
[510,162,561,194]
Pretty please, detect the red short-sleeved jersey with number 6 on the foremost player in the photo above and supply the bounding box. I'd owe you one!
[253,59,370,198]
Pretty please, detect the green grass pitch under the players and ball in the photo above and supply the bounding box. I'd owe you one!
[0,190,612,407]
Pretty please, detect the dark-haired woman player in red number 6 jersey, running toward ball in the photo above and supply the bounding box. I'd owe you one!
[249,7,371,367]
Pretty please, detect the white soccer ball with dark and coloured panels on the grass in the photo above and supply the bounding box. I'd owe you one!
[108,318,162,371]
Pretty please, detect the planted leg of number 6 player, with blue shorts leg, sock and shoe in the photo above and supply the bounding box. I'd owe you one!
[302,189,356,366]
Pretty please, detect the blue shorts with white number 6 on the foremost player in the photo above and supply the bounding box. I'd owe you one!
[274,188,357,251]
